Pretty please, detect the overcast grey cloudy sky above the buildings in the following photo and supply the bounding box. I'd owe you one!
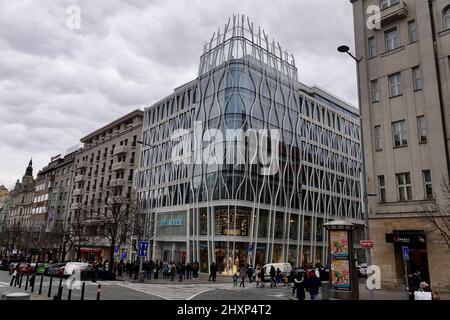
[0,0,357,187]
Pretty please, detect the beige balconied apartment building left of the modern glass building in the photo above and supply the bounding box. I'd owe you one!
[68,110,143,260]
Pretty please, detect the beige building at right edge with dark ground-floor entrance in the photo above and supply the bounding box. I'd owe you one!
[351,0,450,290]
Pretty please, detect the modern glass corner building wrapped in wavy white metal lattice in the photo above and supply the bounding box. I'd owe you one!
[135,16,364,274]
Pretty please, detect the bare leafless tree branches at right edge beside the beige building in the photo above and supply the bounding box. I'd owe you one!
[422,178,450,249]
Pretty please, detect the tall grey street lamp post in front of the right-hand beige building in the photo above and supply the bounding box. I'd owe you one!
[337,45,376,299]
